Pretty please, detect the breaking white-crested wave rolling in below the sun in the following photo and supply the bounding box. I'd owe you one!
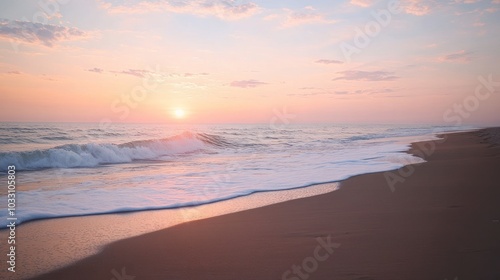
[0,132,232,170]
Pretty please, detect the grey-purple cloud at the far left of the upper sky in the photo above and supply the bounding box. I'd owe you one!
[0,19,88,47]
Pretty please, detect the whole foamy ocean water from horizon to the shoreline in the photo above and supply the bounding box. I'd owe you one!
[0,123,471,226]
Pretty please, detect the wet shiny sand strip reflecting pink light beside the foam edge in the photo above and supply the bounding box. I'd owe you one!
[0,179,339,279]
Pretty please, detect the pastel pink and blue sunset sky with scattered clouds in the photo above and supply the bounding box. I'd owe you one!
[0,0,500,126]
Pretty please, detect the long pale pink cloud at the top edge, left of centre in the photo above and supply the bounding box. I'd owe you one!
[100,0,260,20]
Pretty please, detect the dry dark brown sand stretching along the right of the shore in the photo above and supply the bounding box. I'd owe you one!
[27,129,500,280]
